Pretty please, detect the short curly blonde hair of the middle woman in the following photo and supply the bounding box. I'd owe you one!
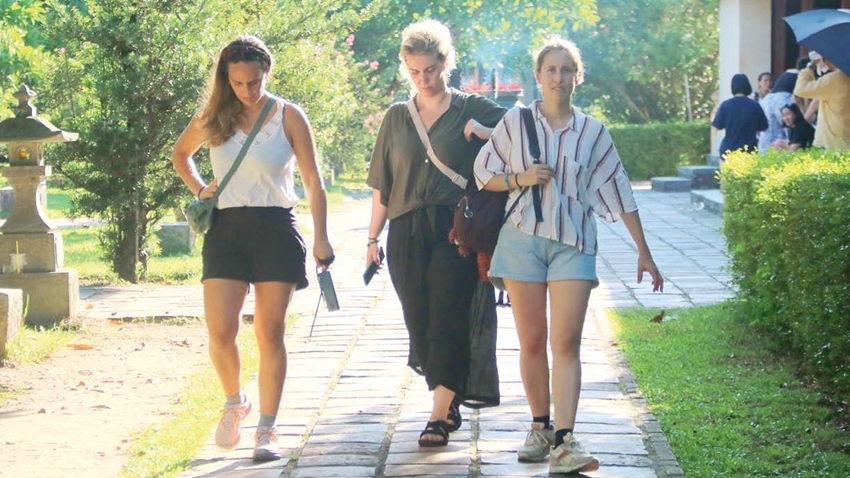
[398,20,457,84]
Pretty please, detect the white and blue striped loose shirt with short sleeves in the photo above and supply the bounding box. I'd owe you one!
[475,101,637,254]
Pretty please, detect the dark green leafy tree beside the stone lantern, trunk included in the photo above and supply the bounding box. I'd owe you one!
[45,0,243,282]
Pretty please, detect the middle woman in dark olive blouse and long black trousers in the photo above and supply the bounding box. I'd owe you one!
[366,20,507,447]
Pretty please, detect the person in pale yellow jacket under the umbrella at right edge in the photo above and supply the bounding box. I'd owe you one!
[794,53,850,150]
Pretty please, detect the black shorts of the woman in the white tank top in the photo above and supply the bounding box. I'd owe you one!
[201,207,308,290]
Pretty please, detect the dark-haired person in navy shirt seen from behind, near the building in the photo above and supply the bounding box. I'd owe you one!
[711,73,767,159]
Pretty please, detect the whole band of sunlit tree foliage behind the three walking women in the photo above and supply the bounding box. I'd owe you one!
[0,0,718,281]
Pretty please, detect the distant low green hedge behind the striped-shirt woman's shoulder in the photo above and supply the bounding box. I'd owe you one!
[608,121,711,181]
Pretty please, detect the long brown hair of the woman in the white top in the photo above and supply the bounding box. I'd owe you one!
[198,35,274,146]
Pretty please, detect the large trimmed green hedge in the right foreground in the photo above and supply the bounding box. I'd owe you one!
[721,150,850,397]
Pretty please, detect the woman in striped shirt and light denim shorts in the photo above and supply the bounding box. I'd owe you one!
[475,38,664,473]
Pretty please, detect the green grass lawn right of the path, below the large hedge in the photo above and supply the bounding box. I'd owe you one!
[609,304,850,478]
